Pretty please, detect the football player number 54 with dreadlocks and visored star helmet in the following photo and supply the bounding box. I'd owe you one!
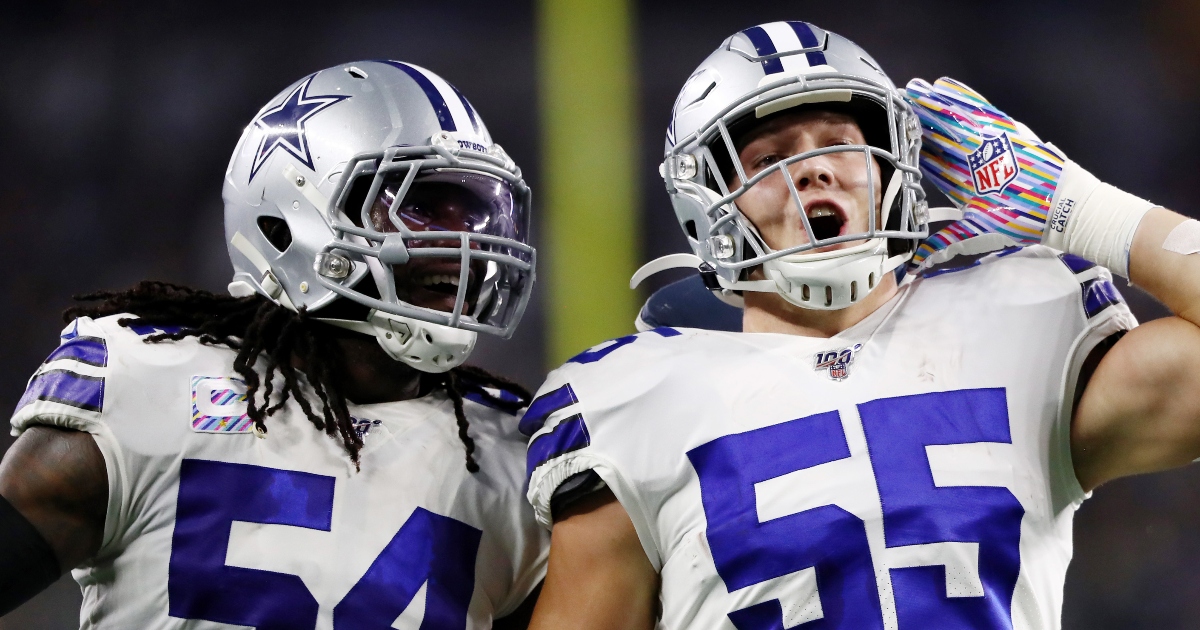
[0,61,548,630]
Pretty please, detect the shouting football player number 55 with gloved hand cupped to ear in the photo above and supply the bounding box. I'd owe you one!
[521,22,1200,630]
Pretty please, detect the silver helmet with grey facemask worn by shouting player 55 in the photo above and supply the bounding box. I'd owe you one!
[634,22,929,310]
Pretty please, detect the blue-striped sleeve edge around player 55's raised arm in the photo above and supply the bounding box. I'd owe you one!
[1051,254,1138,506]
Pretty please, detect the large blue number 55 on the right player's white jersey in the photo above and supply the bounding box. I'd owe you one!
[688,389,1025,630]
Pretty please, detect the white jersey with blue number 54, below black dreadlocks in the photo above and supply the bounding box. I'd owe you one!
[12,317,548,630]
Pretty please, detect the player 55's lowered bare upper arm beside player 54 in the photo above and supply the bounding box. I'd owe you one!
[529,490,659,630]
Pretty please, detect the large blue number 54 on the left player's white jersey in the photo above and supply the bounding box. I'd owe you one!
[167,460,482,630]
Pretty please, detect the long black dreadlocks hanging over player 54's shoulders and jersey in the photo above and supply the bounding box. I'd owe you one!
[62,281,533,473]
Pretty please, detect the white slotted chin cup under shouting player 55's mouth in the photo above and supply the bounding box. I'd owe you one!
[762,239,908,311]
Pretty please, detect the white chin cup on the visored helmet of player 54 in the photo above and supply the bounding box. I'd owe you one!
[367,310,476,373]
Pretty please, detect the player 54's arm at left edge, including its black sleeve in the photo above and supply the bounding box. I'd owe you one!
[0,426,108,616]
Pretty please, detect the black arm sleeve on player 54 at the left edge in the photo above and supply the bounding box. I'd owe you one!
[0,496,61,617]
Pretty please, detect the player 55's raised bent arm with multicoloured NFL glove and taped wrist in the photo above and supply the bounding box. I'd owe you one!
[907,78,1200,490]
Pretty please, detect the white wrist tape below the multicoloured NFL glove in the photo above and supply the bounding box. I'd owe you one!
[1042,160,1154,277]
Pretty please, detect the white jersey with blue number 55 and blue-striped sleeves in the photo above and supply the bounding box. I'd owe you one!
[522,247,1136,630]
